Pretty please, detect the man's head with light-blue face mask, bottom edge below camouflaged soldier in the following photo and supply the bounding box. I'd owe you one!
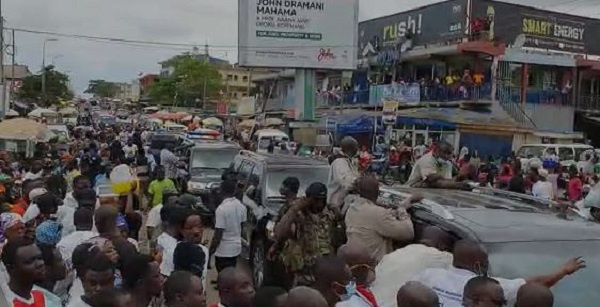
[314,256,356,307]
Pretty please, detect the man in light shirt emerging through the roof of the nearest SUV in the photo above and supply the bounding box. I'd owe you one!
[406,142,468,189]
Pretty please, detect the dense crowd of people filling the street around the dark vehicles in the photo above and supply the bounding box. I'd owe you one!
[0,119,585,307]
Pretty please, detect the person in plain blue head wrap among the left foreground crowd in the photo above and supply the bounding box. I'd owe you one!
[35,220,67,291]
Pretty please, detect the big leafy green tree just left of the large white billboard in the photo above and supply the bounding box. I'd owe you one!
[148,54,222,106]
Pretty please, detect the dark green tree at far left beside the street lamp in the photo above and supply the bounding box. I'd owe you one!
[17,65,73,107]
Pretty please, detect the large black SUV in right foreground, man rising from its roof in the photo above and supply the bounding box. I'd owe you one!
[380,187,600,307]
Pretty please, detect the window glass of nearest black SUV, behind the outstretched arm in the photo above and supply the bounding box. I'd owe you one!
[488,240,600,307]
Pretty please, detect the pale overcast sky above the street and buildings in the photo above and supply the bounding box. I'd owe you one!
[0,0,600,93]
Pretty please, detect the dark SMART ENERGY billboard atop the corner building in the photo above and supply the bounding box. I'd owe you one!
[473,0,600,55]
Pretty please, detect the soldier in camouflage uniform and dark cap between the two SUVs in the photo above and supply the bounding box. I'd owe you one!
[274,182,336,286]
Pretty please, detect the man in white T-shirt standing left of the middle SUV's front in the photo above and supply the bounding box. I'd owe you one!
[210,181,247,272]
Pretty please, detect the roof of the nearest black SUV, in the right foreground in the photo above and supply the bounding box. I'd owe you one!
[383,188,600,243]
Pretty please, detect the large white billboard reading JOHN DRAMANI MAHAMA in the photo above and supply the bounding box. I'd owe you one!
[238,0,358,70]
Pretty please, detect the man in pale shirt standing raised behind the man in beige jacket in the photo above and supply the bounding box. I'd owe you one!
[327,136,359,212]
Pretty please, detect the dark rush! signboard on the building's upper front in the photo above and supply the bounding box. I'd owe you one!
[358,0,467,65]
